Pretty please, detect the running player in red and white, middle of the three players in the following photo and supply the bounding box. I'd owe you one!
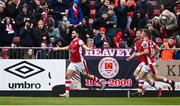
[127,37,161,96]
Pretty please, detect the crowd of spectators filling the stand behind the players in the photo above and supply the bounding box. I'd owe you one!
[0,0,180,59]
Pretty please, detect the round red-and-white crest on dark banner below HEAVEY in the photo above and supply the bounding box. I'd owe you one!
[98,57,119,78]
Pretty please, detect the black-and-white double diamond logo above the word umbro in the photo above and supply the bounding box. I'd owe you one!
[4,61,45,79]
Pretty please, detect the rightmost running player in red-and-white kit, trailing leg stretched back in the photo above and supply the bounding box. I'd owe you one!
[136,29,175,91]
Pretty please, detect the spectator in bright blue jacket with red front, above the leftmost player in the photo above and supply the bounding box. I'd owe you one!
[68,0,83,27]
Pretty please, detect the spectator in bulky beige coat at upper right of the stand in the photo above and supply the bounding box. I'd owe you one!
[159,10,178,38]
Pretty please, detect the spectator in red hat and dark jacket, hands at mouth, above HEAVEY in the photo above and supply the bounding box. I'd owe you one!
[94,27,111,48]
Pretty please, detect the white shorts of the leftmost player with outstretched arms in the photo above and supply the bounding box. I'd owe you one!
[67,62,84,73]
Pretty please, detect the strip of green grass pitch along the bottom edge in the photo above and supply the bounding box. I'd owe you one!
[0,97,180,105]
